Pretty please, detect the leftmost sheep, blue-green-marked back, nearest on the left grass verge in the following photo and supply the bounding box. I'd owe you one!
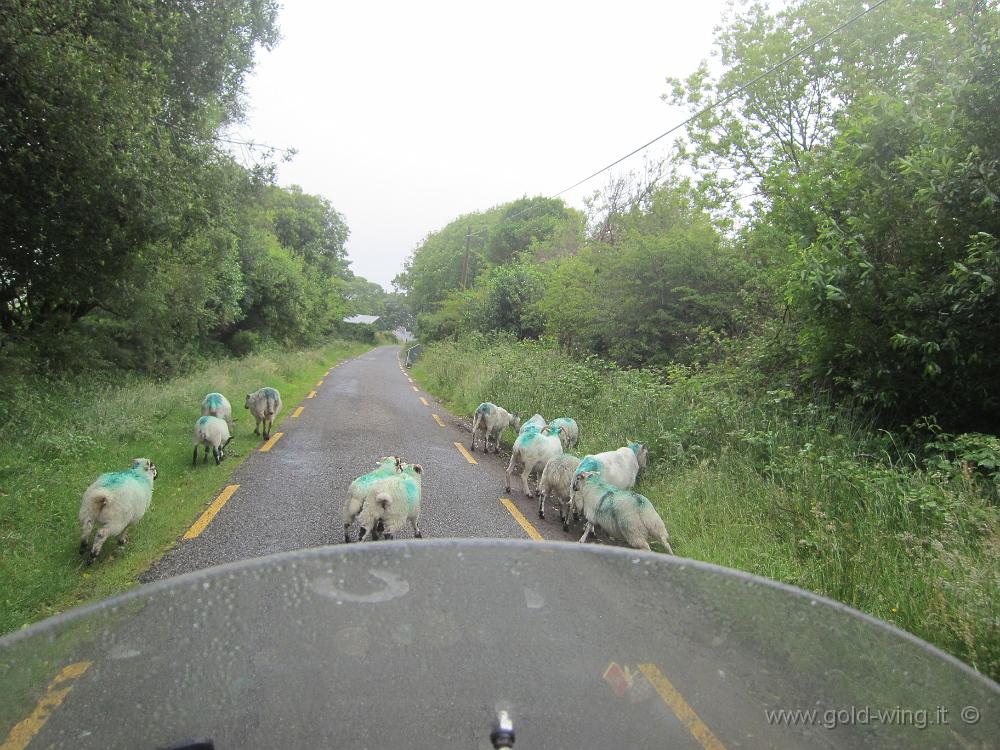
[80,458,156,565]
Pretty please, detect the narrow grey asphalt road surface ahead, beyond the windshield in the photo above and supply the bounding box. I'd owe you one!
[143,346,582,582]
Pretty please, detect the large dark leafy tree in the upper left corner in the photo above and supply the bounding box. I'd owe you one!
[0,0,277,333]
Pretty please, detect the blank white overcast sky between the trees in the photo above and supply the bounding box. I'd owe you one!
[235,0,727,289]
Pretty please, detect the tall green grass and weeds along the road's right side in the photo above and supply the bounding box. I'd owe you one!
[414,337,1000,679]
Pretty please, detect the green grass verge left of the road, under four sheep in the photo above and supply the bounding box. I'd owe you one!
[0,341,370,634]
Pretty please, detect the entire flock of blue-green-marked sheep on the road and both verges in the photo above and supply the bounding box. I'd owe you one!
[80,387,673,563]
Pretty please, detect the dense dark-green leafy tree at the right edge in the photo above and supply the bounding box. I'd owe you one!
[774,5,1000,431]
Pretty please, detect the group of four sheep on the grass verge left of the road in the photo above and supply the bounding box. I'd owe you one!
[80,386,281,564]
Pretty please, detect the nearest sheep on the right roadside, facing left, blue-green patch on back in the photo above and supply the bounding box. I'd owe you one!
[573,471,674,555]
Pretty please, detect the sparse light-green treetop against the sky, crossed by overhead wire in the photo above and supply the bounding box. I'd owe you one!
[663,0,956,212]
